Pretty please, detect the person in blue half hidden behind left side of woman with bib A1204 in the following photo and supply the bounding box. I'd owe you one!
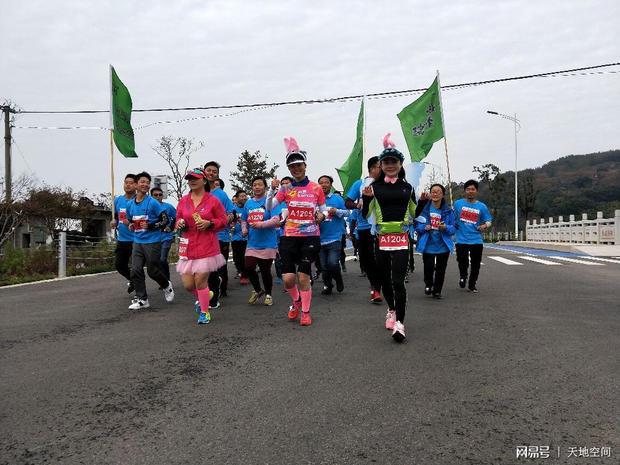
[345,157,383,303]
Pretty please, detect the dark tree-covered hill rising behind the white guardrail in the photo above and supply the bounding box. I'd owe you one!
[455,150,620,230]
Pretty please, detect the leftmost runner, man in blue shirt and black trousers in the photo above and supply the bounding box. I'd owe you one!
[110,174,136,294]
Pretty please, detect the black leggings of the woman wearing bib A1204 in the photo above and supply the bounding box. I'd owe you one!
[376,245,409,323]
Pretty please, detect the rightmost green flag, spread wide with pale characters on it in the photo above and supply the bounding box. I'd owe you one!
[398,78,443,162]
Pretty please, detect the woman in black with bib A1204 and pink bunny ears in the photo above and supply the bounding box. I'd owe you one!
[362,133,415,342]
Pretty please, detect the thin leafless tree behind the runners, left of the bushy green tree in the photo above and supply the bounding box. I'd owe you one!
[152,136,204,201]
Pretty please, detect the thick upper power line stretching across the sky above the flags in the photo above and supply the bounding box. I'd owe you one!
[17,62,620,115]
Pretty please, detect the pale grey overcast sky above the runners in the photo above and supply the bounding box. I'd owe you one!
[0,0,620,198]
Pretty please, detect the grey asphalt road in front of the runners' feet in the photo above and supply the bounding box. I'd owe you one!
[0,250,620,465]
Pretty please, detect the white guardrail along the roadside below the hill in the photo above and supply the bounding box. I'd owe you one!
[525,210,620,245]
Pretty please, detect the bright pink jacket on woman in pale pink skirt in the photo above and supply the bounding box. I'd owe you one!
[177,192,228,260]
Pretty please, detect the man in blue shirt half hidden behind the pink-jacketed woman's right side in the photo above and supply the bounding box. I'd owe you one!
[204,161,234,308]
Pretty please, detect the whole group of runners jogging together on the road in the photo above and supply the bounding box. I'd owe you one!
[113,134,491,342]
